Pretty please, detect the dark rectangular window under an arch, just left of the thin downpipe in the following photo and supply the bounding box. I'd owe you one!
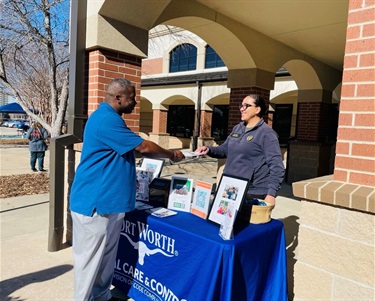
[167,105,195,138]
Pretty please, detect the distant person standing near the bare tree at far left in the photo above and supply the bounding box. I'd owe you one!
[25,122,48,172]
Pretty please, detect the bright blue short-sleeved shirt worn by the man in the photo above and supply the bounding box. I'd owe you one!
[70,102,143,216]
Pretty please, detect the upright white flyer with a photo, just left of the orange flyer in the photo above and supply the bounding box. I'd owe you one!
[168,177,193,212]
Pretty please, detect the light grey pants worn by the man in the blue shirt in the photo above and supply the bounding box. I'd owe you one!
[71,211,125,301]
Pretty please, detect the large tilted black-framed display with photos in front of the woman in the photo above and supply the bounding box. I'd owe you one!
[208,174,249,225]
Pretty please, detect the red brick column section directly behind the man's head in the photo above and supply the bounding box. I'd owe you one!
[88,49,141,133]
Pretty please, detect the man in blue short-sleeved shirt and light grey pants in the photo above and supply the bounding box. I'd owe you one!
[70,78,184,301]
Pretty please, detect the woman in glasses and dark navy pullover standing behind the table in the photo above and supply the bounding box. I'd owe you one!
[196,94,285,205]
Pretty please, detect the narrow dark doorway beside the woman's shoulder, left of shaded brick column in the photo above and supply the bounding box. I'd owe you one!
[272,104,293,146]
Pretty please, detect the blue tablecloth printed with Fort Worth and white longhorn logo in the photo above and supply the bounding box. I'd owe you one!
[113,211,288,301]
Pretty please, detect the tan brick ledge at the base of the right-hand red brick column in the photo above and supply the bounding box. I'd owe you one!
[292,175,375,214]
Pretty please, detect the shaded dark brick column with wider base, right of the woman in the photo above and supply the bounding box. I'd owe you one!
[286,90,337,183]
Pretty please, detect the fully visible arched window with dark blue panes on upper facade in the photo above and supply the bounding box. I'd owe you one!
[169,44,197,72]
